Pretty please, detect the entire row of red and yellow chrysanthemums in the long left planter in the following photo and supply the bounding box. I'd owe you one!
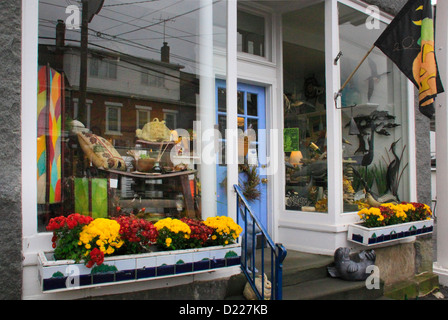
[47,213,242,268]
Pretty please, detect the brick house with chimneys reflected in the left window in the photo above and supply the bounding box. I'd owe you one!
[39,32,197,148]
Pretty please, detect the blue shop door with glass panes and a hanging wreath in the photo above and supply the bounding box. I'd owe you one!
[216,80,269,230]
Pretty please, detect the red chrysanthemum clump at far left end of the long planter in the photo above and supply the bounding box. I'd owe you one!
[47,213,93,261]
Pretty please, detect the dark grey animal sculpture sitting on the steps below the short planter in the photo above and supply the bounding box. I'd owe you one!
[327,247,376,281]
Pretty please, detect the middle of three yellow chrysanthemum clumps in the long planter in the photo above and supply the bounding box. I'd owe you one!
[154,218,191,250]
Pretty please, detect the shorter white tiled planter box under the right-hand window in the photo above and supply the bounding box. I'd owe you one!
[347,219,434,246]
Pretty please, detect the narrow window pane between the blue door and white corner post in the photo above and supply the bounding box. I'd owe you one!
[282,2,327,212]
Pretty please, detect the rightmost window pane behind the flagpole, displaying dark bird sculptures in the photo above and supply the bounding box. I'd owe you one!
[338,4,410,212]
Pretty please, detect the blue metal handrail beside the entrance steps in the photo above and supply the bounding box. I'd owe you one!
[233,184,286,300]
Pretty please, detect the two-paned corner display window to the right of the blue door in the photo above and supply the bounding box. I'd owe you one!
[282,2,410,213]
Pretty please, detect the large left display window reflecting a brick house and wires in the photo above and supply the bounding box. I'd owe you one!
[36,0,228,232]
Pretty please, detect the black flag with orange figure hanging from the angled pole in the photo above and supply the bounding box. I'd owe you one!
[375,0,444,118]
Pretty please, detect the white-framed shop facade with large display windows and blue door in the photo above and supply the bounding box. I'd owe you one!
[0,0,440,299]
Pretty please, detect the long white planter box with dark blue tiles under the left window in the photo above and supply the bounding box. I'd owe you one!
[38,244,241,292]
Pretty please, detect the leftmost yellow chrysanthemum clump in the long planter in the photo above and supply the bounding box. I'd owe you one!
[78,218,124,268]
